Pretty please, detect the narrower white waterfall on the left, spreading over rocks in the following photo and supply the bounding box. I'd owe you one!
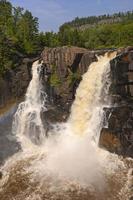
[12,61,47,146]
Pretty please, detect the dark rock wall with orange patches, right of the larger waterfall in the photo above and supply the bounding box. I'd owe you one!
[99,48,133,157]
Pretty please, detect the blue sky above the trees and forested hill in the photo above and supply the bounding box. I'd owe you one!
[10,0,133,31]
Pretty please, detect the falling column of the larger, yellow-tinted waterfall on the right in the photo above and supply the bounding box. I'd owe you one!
[69,53,116,140]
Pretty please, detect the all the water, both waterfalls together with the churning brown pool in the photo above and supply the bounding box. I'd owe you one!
[0,53,133,200]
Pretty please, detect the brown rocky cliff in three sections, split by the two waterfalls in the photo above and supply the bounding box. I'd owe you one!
[0,47,133,156]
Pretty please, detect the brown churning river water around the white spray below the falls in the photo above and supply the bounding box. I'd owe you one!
[0,147,133,200]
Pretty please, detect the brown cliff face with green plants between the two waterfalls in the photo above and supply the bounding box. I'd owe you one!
[41,47,96,121]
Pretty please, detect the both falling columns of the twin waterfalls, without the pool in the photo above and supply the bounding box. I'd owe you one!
[13,53,116,148]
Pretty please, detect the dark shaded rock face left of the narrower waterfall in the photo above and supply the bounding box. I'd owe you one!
[0,58,37,113]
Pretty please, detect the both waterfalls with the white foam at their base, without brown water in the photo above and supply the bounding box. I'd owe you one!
[0,53,132,199]
